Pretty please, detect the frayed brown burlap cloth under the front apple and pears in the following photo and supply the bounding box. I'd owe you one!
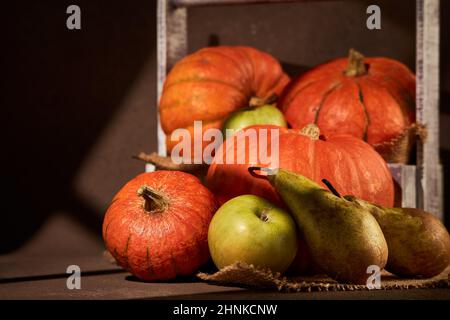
[197,262,450,292]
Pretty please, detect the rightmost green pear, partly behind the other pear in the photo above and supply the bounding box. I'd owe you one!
[345,196,450,278]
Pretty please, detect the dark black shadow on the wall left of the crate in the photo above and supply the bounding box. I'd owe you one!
[0,0,156,253]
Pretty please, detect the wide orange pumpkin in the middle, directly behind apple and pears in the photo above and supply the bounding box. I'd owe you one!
[206,125,394,206]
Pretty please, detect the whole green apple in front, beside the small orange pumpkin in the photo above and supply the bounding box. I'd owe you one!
[208,195,297,272]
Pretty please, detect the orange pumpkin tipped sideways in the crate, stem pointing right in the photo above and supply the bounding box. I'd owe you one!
[159,46,289,156]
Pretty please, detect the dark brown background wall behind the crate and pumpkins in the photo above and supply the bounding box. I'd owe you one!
[0,0,450,260]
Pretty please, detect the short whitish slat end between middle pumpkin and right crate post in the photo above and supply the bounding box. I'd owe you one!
[389,163,417,208]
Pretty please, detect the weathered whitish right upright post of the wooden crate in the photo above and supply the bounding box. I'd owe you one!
[416,0,443,219]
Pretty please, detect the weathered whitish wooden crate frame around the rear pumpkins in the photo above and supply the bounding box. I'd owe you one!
[153,0,443,219]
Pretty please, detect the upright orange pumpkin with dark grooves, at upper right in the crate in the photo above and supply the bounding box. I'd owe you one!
[278,50,416,162]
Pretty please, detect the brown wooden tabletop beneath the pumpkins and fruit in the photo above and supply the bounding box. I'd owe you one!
[0,273,450,300]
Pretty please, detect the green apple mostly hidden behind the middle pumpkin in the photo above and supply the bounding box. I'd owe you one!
[222,104,287,135]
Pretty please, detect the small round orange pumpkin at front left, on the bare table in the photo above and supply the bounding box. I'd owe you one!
[103,171,217,280]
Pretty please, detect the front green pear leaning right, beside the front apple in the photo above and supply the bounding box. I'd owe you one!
[249,167,388,284]
